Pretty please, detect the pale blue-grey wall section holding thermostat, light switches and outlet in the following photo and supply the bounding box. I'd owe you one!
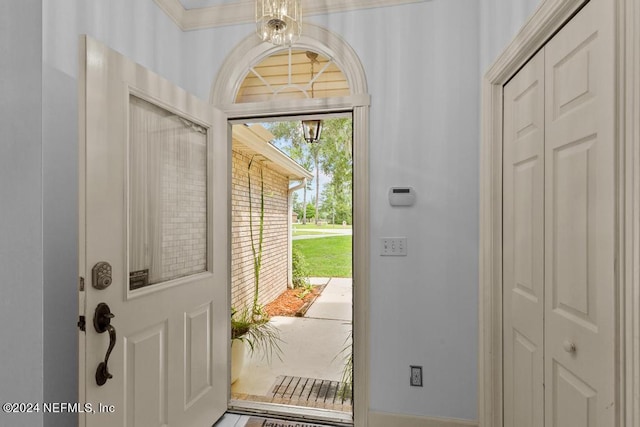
[313,0,479,419]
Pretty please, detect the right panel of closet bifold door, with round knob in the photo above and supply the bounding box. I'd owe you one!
[545,0,616,427]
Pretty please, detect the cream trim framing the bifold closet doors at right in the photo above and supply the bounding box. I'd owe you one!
[478,0,640,427]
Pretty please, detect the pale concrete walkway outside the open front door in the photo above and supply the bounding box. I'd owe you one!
[231,278,352,396]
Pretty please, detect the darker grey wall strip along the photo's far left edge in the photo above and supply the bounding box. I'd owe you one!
[0,0,43,427]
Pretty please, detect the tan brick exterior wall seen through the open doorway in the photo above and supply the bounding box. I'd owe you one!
[231,151,289,309]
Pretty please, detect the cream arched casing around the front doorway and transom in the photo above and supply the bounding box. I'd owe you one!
[209,24,371,427]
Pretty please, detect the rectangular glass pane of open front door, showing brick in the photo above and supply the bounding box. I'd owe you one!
[130,97,207,284]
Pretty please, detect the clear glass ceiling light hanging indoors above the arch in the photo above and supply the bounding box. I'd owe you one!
[256,0,302,46]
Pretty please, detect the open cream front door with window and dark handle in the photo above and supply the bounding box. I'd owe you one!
[79,38,229,427]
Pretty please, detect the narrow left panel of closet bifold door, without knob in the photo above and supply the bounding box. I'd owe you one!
[503,48,544,427]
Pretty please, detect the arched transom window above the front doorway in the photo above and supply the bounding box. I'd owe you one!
[236,47,350,103]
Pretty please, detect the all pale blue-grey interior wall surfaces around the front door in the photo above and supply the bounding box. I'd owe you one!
[0,0,535,426]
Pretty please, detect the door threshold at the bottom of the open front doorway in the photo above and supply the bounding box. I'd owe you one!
[227,399,353,427]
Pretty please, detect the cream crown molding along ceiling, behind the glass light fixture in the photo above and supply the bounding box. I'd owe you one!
[154,0,429,31]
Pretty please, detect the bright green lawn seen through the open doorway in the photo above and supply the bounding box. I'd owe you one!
[293,236,352,277]
